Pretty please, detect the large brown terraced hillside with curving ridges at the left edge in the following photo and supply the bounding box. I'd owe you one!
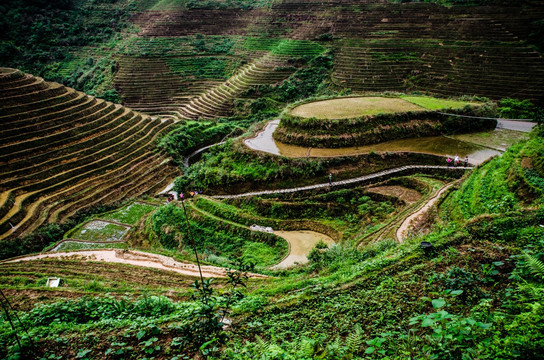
[0,68,183,239]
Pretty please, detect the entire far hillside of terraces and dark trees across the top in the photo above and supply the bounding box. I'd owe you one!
[0,0,544,118]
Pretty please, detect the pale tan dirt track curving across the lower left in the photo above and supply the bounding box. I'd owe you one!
[5,249,267,278]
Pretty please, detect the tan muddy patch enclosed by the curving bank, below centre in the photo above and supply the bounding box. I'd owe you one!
[271,230,334,270]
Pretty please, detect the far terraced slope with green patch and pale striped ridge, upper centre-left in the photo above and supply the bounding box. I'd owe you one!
[115,33,325,119]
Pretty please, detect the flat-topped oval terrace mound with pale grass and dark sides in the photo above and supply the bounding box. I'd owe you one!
[273,96,497,148]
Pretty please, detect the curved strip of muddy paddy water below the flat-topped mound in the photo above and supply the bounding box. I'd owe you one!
[244,120,500,164]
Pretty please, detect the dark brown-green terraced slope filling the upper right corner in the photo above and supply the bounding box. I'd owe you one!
[267,0,544,100]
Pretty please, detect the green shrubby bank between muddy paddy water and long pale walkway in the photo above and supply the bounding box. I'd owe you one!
[174,141,443,194]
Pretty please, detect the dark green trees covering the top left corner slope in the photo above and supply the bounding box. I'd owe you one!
[0,0,129,94]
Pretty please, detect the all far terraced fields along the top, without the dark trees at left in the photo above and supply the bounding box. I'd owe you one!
[104,0,544,119]
